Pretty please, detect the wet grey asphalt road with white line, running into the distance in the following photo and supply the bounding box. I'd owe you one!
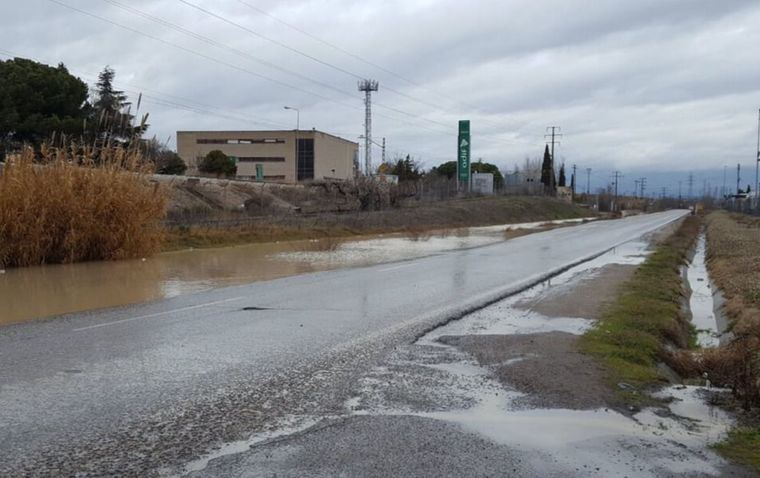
[0,211,686,476]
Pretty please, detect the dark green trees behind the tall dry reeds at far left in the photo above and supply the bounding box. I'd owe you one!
[0,58,186,174]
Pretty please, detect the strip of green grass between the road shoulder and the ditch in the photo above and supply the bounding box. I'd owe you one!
[581,216,700,392]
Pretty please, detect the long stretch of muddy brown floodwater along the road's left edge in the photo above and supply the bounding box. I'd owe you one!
[0,219,581,325]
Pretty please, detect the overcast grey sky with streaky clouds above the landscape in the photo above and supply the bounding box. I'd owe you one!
[0,0,760,190]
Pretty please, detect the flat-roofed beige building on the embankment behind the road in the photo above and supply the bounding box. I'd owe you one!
[177,130,359,183]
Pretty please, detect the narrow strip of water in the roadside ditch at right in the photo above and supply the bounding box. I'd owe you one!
[686,234,721,347]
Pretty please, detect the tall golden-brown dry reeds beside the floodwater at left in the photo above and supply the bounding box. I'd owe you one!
[0,143,167,267]
